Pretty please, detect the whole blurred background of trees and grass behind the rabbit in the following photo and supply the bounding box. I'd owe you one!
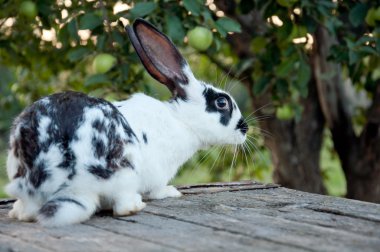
[0,0,380,201]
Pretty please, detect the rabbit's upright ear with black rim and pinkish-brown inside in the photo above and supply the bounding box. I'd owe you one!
[126,19,189,98]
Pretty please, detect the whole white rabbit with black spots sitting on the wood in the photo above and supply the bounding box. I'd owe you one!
[6,19,248,227]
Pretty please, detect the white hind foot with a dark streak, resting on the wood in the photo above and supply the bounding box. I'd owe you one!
[37,195,97,227]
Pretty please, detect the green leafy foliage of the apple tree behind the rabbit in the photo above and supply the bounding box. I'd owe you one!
[0,0,380,197]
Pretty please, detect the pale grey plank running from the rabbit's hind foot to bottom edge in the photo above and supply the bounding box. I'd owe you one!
[89,212,307,251]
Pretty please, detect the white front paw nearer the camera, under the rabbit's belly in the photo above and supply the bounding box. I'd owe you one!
[113,194,146,216]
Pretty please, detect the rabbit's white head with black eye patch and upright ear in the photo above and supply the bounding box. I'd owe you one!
[127,19,248,146]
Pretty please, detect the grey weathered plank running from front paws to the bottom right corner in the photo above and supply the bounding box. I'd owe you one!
[146,198,380,251]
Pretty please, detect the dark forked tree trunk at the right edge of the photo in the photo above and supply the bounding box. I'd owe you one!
[312,27,380,203]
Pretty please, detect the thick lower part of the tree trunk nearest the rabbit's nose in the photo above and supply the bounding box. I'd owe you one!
[252,80,325,194]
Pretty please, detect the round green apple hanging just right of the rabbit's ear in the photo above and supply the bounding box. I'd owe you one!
[187,26,212,51]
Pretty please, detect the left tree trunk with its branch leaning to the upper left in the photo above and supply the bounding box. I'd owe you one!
[215,0,325,194]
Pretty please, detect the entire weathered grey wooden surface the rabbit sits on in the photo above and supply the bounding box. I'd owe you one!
[0,182,380,252]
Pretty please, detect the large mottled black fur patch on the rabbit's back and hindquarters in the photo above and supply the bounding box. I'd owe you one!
[10,91,138,188]
